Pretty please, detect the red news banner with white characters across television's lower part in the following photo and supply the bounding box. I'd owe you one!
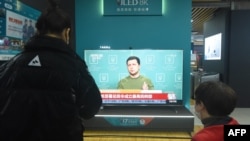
[101,90,168,104]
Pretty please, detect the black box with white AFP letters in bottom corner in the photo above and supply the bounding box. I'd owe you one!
[224,125,250,141]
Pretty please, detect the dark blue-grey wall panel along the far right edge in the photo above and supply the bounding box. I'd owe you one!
[228,10,250,108]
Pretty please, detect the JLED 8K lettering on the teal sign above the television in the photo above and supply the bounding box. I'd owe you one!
[117,0,148,6]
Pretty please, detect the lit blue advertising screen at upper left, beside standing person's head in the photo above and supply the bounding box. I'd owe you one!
[0,0,41,60]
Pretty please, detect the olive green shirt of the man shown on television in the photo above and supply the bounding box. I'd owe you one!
[117,75,154,90]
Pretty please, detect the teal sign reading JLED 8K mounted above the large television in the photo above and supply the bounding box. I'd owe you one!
[103,0,162,16]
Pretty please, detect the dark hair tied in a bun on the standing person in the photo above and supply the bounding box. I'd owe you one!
[36,0,71,35]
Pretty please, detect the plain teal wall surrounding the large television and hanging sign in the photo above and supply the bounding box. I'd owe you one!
[75,0,192,105]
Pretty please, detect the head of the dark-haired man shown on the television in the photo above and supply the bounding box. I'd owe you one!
[127,56,140,77]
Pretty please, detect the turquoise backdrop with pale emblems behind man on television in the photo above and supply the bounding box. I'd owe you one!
[84,50,183,100]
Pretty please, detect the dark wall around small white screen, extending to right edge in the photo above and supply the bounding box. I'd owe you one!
[203,9,250,108]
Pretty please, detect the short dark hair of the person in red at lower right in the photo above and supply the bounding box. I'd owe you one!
[194,81,237,116]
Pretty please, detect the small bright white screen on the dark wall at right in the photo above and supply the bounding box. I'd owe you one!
[204,33,222,60]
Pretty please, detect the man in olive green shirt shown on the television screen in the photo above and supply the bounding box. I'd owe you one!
[117,56,154,90]
